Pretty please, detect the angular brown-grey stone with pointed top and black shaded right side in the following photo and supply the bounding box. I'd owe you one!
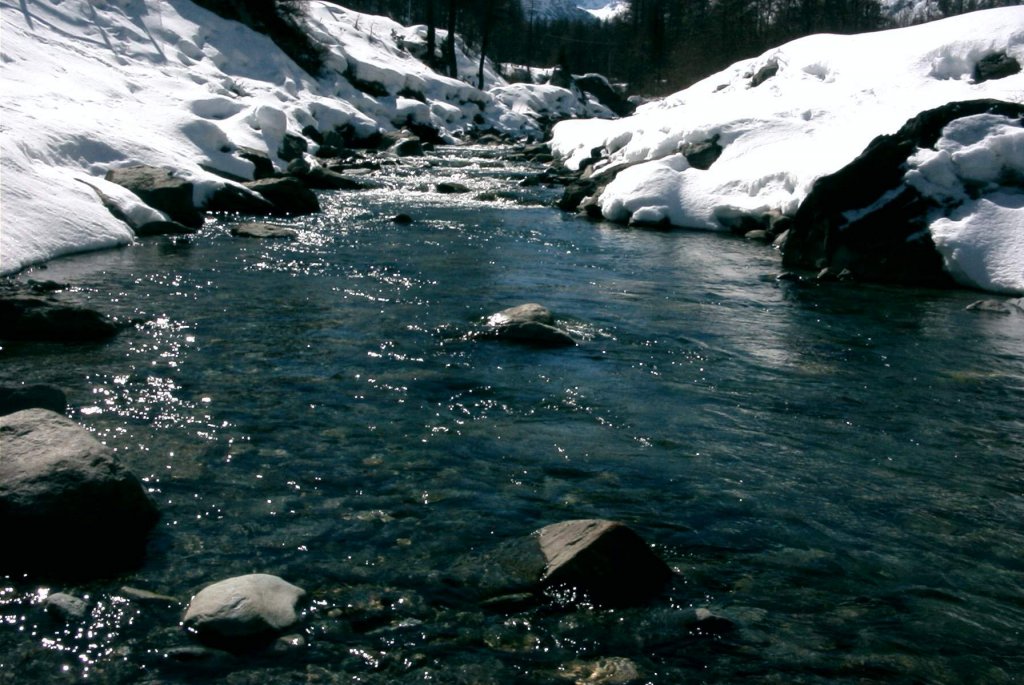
[535,519,672,605]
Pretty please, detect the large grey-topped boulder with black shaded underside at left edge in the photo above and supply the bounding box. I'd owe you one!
[0,409,158,579]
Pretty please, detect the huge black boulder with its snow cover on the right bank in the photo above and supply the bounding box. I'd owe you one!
[782,100,1024,294]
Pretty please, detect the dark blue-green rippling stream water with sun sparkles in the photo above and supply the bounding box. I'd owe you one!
[0,148,1024,684]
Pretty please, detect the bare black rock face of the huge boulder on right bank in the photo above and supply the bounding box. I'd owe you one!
[781,99,1024,285]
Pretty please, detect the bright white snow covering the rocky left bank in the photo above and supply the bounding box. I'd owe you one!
[0,0,595,274]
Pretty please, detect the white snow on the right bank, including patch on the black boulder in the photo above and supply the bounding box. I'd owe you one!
[552,6,1024,293]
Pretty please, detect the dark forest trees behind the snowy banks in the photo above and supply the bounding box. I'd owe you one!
[197,0,1019,95]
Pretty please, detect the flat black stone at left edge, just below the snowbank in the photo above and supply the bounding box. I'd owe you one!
[0,296,120,343]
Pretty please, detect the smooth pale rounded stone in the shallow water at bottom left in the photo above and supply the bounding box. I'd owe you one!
[182,573,306,648]
